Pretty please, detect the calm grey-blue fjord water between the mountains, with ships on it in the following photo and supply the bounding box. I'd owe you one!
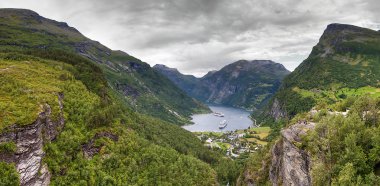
[183,105,252,132]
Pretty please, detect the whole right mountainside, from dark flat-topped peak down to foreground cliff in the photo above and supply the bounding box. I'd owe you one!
[239,24,380,185]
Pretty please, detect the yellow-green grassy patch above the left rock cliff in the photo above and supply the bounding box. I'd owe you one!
[0,59,74,131]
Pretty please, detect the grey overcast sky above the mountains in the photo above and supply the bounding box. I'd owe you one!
[0,0,380,76]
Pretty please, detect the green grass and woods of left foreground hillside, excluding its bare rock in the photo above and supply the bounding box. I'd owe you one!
[0,51,236,185]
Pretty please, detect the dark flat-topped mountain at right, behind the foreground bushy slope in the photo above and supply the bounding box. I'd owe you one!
[269,24,380,119]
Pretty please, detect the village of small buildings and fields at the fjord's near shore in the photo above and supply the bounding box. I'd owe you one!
[194,127,271,158]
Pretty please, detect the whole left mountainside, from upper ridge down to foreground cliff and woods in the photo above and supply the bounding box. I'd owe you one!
[0,9,237,186]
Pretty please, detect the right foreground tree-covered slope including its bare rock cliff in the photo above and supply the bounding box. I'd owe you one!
[239,95,380,185]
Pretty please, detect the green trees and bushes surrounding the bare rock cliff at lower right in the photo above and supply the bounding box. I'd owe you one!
[239,96,380,185]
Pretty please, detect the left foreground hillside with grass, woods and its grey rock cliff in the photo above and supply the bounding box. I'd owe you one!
[0,53,216,185]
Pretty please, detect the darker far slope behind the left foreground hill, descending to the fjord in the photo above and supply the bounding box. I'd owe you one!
[0,9,208,123]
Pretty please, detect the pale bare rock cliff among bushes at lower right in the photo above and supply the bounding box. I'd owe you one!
[269,121,315,186]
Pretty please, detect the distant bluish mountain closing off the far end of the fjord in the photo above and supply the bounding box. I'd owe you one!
[153,60,289,110]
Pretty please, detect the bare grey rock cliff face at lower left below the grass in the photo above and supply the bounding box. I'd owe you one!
[0,94,64,185]
